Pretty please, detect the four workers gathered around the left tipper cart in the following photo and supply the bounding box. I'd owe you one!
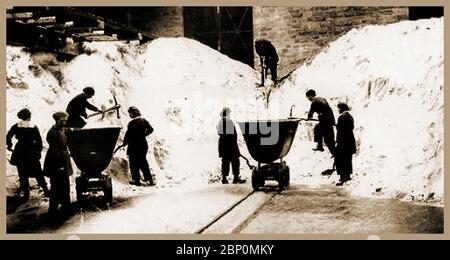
[6,87,154,217]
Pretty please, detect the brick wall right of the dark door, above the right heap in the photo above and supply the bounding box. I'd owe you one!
[253,7,408,77]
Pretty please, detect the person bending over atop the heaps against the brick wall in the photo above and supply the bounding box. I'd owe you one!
[255,40,279,84]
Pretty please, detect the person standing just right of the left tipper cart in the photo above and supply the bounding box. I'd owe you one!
[118,106,155,186]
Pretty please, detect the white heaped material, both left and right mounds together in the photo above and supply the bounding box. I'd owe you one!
[6,19,444,205]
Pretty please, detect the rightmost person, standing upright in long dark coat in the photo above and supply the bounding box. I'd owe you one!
[334,103,356,186]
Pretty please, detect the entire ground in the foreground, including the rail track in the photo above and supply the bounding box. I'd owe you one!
[7,183,444,234]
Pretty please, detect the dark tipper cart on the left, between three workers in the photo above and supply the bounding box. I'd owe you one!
[67,127,121,204]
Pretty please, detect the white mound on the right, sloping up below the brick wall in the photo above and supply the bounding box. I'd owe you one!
[271,18,444,205]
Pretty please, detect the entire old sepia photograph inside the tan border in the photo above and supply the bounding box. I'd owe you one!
[4,3,444,234]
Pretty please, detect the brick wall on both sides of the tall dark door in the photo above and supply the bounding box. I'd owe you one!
[123,6,409,77]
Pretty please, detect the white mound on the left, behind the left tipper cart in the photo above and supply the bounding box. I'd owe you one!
[7,38,263,187]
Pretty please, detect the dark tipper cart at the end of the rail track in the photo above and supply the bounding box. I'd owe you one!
[238,117,300,190]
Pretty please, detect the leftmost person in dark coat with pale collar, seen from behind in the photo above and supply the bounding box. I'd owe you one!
[6,108,50,199]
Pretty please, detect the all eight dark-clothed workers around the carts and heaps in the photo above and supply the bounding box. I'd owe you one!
[6,40,356,220]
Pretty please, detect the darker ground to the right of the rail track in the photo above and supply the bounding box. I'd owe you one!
[239,185,444,234]
